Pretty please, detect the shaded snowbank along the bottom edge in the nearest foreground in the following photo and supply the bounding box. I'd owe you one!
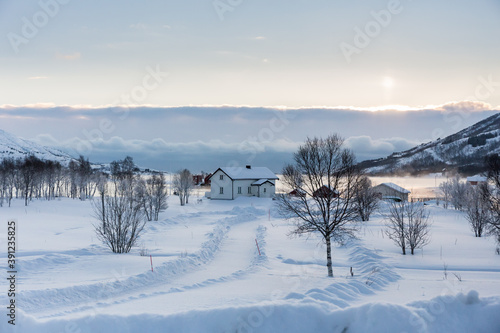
[4,291,500,333]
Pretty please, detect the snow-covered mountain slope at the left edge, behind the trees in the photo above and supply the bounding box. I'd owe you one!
[0,130,74,165]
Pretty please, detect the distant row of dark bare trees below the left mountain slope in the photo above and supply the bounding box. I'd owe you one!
[0,155,166,220]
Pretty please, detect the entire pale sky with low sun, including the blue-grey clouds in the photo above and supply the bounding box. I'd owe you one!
[0,0,500,170]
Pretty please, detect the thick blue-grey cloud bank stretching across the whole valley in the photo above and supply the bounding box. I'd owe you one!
[0,102,498,172]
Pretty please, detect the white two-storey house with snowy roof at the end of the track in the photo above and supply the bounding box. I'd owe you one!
[207,165,278,200]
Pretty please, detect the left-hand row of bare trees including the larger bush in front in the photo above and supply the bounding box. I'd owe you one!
[0,155,172,253]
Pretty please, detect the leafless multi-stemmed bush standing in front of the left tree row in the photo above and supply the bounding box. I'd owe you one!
[92,179,146,253]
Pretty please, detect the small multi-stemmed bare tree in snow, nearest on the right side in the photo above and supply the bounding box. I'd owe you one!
[385,201,430,255]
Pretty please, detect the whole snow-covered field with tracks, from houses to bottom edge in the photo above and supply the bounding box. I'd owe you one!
[0,188,500,333]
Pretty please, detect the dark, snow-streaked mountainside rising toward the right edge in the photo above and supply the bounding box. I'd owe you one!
[359,113,500,174]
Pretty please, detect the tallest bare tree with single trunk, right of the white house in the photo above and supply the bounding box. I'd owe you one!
[277,135,360,277]
